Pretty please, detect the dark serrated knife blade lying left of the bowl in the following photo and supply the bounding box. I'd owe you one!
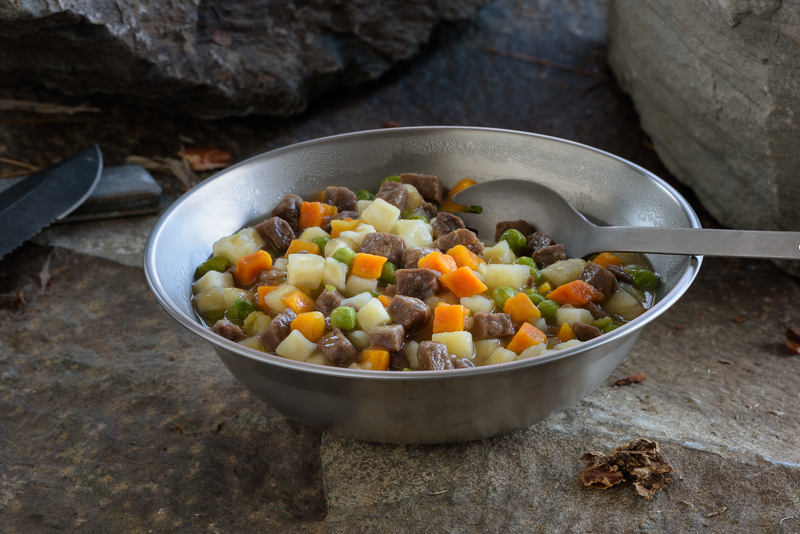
[0,145,103,258]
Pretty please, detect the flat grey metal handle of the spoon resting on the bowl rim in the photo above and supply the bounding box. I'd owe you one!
[589,226,800,260]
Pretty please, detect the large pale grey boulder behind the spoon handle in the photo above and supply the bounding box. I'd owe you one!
[608,0,800,234]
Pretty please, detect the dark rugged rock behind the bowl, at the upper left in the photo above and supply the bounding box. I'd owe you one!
[0,0,488,118]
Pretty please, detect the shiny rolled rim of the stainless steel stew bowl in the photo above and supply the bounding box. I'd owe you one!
[143,126,703,381]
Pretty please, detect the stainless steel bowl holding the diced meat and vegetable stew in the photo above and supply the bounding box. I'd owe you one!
[144,127,702,443]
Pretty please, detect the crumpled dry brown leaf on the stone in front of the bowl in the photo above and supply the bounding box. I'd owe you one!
[578,438,674,501]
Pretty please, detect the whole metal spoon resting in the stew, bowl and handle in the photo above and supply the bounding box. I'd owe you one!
[452,179,800,259]
